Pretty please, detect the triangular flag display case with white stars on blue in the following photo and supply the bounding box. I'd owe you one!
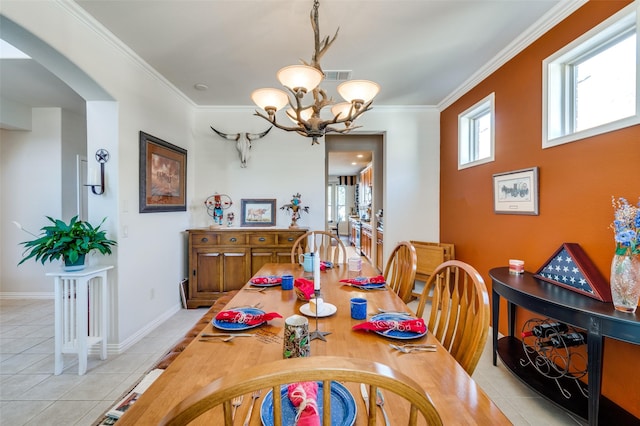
[535,243,612,302]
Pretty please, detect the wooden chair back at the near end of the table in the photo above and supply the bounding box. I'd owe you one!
[160,356,442,426]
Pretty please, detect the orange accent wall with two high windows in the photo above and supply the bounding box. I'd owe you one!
[440,0,640,417]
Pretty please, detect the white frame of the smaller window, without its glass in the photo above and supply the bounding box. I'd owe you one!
[458,93,496,170]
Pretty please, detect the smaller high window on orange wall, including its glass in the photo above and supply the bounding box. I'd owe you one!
[458,93,495,170]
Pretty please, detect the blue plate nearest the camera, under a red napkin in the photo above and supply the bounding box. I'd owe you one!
[260,382,356,426]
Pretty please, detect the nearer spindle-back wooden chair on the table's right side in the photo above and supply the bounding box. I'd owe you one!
[416,260,489,375]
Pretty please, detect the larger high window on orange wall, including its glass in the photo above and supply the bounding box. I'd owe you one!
[542,3,640,148]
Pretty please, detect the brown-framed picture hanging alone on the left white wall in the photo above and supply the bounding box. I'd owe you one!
[140,132,187,213]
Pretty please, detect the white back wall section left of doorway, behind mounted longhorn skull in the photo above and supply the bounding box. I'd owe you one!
[189,107,325,229]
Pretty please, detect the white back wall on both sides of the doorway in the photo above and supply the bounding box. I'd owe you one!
[190,107,440,259]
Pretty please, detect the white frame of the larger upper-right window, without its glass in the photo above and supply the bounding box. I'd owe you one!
[542,2,640,149]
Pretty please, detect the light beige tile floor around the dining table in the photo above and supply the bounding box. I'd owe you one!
[0,294,583,426]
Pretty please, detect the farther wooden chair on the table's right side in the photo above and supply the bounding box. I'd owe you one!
[383,241,418,303]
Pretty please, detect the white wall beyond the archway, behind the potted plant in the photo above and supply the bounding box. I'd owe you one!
[0,108,62,297]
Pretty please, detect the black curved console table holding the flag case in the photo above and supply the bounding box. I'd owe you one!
[489,267,640,425]
